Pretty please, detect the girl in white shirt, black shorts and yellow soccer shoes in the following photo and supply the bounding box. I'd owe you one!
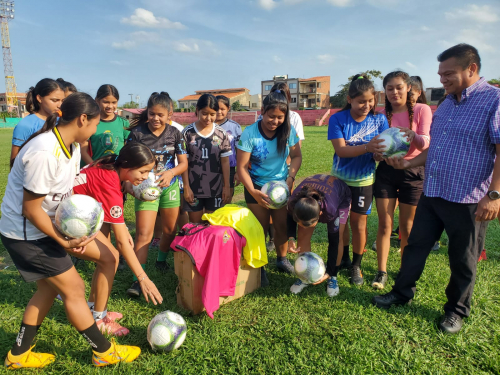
[0,93,141,369]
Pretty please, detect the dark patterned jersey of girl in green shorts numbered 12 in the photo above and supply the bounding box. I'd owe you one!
[127,124,186,184]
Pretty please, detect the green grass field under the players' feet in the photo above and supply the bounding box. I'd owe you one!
[0,127,500,375]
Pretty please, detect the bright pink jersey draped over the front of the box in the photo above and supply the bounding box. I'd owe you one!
[170,223,247,319]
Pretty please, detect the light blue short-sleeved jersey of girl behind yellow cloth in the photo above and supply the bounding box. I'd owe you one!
[238,121,299,186]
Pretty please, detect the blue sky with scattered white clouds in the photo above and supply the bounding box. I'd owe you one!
[6,0,500,103]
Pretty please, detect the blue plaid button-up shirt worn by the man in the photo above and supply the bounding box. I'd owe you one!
[424,78,500,204]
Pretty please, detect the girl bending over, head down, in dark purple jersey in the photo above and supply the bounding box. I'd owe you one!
[288,174,351,297]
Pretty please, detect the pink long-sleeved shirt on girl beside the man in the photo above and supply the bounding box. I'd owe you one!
[381,103,432,159]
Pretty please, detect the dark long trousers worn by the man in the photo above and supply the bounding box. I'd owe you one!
[392,194,487,317]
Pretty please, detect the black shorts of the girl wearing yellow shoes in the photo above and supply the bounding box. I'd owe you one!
[0,235,73,282]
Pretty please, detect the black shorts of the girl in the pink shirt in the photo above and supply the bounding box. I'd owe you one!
[373,161,425,206]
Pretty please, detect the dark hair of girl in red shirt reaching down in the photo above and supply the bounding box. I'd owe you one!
[91,142,158,171]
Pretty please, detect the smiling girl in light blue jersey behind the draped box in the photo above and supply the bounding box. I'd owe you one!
[237,90,302,274]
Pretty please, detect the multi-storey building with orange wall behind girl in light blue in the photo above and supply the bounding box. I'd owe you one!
[261,75,330,109]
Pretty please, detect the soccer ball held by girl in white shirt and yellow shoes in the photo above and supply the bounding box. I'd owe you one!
[55,194,104,238]
